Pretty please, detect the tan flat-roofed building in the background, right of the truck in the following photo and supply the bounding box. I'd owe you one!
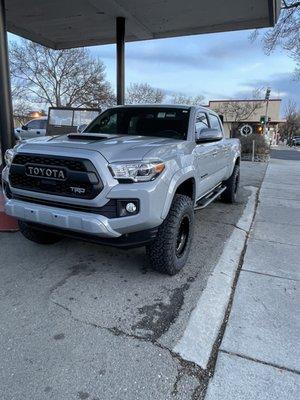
[208,99,284,145]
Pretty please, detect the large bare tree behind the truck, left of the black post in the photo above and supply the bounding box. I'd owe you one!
[10,40,114,107]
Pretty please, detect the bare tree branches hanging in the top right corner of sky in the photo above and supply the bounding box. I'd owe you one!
[251,0,300,79]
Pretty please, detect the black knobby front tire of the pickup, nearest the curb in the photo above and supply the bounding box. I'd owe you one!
[146,194,194,275]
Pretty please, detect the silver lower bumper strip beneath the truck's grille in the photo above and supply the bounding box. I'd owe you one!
[5,199,121,238]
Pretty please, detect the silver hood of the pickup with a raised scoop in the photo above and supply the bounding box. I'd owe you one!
[18,134,187,162]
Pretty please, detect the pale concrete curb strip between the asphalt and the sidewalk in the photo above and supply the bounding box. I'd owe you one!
[173,186,258,369]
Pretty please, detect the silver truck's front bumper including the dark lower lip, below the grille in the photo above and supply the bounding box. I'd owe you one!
[2,168,166,241]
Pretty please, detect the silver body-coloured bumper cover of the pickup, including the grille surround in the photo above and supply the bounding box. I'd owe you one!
[2,150,171,240]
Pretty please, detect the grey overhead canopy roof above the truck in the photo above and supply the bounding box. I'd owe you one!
[5,0,280,49]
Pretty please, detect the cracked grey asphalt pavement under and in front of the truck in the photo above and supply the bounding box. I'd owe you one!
[0,162,266,400]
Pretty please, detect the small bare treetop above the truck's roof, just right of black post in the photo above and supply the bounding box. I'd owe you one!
[126,83,165,104]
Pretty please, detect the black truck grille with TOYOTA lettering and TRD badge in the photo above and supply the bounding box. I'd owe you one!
[9,154,103,199]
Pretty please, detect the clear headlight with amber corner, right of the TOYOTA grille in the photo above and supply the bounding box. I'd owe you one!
[109,161,165,182]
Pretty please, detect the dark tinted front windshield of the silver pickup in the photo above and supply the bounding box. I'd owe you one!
[84,107,190,140]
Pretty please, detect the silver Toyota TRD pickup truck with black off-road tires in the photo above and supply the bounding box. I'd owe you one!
[2,105,240,275]
